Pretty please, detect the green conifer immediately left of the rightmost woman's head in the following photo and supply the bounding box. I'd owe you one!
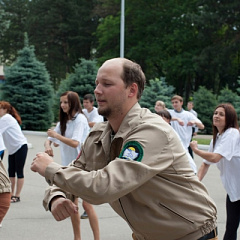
[193,86,217,134]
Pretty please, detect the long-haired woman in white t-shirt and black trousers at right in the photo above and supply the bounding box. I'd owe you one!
[190,104,240,240]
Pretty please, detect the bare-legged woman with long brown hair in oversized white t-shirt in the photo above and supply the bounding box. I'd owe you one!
[45,91,100,240]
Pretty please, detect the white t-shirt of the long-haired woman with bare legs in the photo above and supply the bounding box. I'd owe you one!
[48,113,89,166]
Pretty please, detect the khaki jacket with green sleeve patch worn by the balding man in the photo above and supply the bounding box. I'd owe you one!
[44,104,216,240]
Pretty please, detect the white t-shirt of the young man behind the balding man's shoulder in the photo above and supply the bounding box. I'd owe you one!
[168,109,202,149]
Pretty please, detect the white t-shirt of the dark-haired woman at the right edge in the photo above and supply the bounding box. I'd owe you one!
[204,128,240,202]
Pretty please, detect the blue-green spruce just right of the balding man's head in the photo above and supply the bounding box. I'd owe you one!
[139,77,174,112]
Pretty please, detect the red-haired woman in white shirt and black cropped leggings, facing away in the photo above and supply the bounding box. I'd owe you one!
[0,101,28,203]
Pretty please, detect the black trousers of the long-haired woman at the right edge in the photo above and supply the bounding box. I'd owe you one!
[223,195,240,240]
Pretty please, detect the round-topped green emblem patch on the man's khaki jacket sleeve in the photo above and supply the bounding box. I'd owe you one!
[119,141,143,162]
